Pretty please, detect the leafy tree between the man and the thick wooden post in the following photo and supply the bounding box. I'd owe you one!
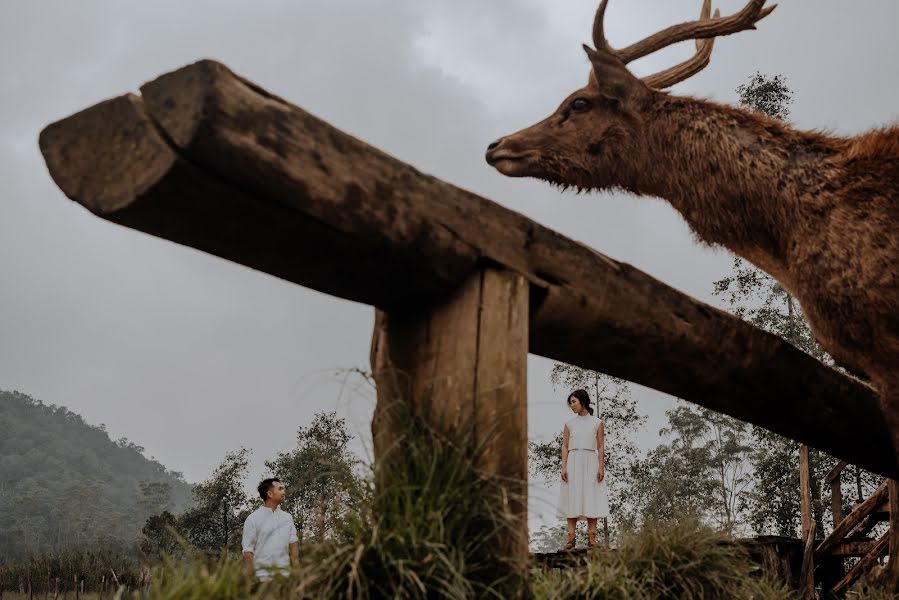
[265,412,365,541]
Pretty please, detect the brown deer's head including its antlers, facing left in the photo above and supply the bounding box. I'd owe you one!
[486,0,776,191]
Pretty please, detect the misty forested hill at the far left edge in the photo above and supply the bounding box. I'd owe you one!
[0,390,191,562]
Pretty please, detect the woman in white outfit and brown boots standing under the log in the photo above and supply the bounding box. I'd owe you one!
[558,390,609,550]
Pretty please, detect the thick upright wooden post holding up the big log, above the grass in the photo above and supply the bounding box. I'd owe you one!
[371,267,529,576]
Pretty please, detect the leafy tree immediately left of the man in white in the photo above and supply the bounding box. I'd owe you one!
[180,448,253,553]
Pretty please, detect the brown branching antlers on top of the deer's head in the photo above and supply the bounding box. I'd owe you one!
[593,0,777,89]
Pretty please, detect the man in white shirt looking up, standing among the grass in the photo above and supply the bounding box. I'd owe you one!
[243,477,299,581]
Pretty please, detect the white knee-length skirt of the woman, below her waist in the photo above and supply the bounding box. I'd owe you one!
[557,450,609,519]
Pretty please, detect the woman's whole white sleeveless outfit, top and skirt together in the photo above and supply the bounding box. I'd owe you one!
[557,415,609,519]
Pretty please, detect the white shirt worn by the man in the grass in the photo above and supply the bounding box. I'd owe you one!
[243,506,297,580]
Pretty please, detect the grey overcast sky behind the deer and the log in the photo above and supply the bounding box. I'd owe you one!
[0,0,899,517]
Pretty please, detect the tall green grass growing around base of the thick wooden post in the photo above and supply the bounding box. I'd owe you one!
[152,394,524,600]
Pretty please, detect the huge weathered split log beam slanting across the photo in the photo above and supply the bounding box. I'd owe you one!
[40,61,899,477]
